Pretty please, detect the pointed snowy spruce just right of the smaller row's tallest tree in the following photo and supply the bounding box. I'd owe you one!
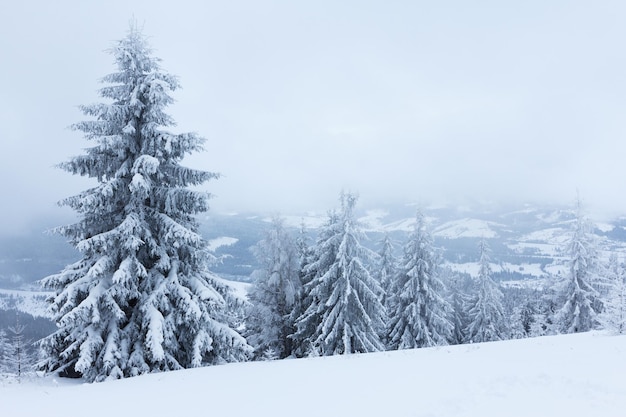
[388,211,453,349]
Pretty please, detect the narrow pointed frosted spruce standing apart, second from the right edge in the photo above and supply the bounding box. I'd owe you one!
[555,199,603,333]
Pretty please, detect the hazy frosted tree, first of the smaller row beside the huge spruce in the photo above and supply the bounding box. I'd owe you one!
[246,217,300,359]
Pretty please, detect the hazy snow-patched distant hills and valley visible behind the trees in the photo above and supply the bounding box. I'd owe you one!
[0,205,626,289]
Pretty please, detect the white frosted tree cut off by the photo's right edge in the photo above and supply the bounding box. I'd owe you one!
[600,253,626,334]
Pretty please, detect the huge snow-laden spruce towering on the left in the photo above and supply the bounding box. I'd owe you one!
[41,28,250,381]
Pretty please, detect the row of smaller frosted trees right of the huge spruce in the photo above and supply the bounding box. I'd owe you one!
[245,194,626,358]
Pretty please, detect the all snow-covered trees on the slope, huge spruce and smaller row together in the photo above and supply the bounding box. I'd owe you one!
[33,27,623,381]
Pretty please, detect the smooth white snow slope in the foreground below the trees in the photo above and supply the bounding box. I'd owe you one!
[0,333,626,417]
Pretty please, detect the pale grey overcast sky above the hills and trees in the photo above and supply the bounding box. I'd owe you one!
[0,0,626,228]
